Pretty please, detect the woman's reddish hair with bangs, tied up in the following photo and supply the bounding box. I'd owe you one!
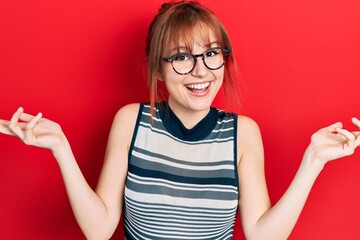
[146,1,238,115]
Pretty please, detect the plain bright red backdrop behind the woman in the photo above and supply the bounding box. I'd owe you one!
[0,0,360,239]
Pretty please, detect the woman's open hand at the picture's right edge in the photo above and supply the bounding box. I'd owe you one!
[307,118,360,164]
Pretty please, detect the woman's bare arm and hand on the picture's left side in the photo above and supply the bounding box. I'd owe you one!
[0,104,139,239]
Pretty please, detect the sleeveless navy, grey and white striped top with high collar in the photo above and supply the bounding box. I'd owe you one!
[124,102,239,240]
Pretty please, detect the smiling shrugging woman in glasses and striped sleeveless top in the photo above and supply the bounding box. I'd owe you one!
[0,2,360,239]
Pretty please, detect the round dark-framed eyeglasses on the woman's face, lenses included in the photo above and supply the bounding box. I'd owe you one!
[163,47,230,75]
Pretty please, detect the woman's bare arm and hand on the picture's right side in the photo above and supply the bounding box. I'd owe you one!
[238,117,360,239]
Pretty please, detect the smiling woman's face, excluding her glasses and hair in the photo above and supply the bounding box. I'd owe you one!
[160,33,224,117]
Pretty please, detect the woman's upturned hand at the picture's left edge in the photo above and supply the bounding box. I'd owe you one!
[0,107,67,152]
